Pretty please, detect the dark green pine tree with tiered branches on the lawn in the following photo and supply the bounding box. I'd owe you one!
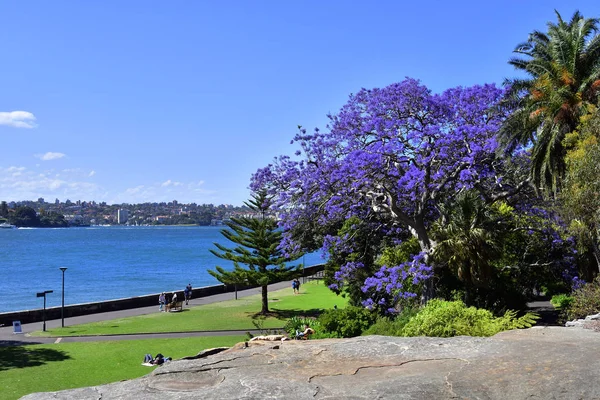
[208,190,301,314]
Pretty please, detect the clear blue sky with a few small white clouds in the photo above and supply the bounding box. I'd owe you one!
[0,0,600,205]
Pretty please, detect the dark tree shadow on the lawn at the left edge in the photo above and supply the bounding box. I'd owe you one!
[0,341,71,371]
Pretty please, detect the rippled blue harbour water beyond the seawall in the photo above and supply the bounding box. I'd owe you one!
[0,226,322,312]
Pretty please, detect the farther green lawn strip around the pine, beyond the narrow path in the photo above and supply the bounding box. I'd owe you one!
[34,281,347,337]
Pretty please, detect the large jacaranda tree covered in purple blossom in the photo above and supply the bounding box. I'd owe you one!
[252,79,525,310]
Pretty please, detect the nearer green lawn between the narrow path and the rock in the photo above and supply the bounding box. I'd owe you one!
[0,336,246,400]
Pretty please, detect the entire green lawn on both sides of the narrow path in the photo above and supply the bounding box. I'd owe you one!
[0,282,347,400]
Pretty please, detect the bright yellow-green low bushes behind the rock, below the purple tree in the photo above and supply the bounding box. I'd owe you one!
[402,299,539,337]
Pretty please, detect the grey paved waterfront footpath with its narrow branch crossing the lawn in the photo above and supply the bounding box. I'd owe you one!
[0,281,292,347]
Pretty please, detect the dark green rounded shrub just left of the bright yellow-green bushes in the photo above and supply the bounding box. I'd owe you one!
[318,306,376,337]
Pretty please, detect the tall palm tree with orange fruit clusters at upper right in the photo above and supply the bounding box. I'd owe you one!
[499,11,600,192]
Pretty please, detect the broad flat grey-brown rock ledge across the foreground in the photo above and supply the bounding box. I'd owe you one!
[24,327,600,400]
